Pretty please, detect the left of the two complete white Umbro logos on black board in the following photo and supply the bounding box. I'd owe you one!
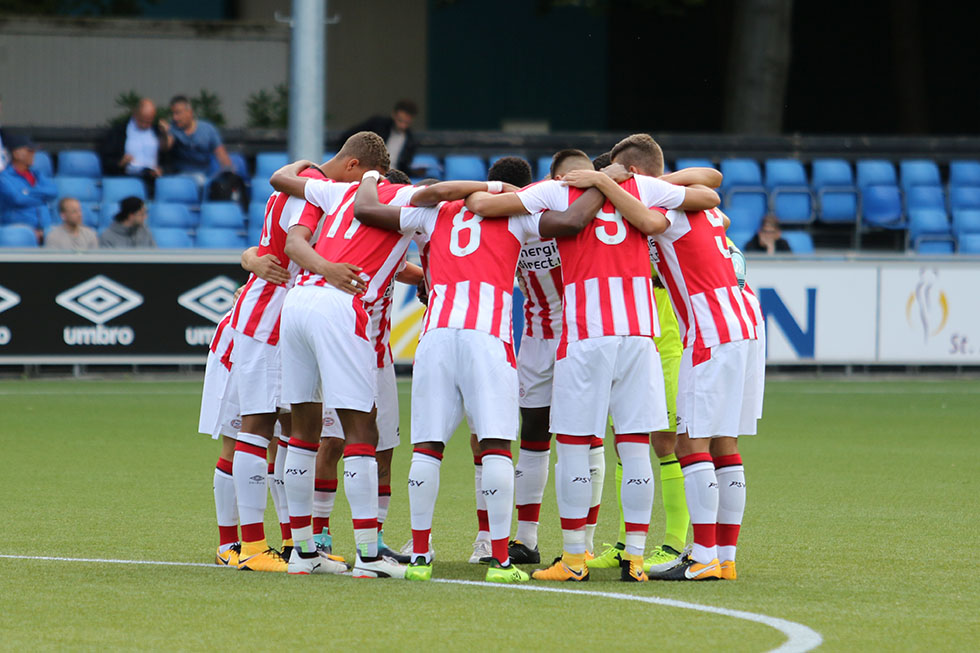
[54,274,143,346]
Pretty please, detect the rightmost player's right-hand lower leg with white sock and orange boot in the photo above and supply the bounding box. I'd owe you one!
[711,437,745,580]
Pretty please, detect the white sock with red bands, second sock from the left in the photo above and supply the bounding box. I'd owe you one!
[231,433,269,543]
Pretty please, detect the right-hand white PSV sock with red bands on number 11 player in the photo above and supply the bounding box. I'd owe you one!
[344,443,378,558]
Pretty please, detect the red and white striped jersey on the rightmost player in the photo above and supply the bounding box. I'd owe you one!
[653,209,755,349]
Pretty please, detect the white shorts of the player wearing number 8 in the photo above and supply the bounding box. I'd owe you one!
[412,328,519,444]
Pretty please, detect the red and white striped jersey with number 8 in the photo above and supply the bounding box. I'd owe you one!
[401,200,541,343]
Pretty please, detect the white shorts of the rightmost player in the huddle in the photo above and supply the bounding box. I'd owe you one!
[677,340,758,438]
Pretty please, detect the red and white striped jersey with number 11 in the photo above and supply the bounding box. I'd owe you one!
[296,181,417,340]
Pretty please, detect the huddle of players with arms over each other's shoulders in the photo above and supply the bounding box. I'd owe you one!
[200,132,765,582]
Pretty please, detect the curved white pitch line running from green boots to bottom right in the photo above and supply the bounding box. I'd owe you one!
[432,578,823,653]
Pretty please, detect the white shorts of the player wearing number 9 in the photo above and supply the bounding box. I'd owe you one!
[551,336,668,438]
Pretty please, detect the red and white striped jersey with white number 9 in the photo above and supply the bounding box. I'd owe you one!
[517,175,684,358]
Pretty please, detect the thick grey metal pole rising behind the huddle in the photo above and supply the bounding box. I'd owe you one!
[289,0,327,163]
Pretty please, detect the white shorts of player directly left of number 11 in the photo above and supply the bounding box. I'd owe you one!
[231,332,282,415]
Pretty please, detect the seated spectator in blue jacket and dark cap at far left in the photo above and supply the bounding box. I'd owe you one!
[0,134,58,242]
